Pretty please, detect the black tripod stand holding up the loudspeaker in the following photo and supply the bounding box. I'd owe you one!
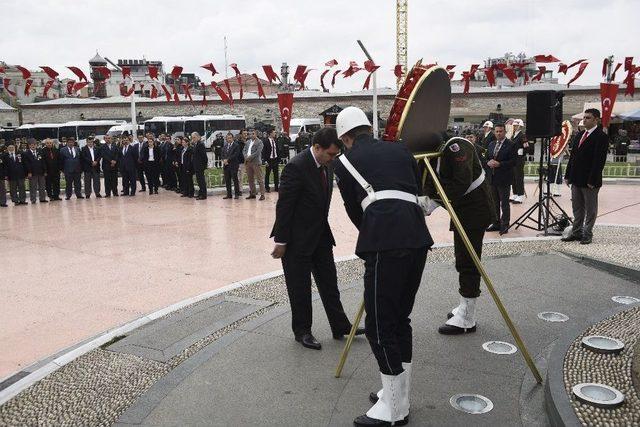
[509,138,569,236]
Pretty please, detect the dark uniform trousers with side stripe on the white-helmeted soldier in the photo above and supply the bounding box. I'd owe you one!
[361,247,427,375]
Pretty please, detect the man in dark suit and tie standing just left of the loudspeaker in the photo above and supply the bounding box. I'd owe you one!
[486,124,517,235]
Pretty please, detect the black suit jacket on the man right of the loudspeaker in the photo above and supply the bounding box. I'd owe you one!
[564,126,609,187]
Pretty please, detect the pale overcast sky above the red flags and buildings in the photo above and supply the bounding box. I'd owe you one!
[0,0,640,92]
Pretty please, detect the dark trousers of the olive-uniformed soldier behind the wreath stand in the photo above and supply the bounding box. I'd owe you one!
[453,227,485,298]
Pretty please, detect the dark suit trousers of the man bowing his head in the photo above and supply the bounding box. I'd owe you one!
[282,235,351,337]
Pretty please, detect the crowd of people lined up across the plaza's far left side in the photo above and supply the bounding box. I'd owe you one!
[0,129,306,207]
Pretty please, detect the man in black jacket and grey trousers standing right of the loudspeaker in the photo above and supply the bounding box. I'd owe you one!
[562,108,609,245]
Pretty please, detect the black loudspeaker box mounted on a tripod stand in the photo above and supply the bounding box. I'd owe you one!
[526,90,564,138]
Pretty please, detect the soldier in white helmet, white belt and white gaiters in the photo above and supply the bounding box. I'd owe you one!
[335,107,433,426]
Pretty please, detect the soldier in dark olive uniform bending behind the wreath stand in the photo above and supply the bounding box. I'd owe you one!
[425,138,495,335]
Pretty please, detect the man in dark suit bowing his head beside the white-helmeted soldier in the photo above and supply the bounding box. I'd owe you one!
[271,128,363,350]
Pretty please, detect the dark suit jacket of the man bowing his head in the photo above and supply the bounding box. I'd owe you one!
[270,149,336,256]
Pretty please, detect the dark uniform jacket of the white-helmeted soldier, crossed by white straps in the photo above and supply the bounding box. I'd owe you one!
[335,135,433,255]
